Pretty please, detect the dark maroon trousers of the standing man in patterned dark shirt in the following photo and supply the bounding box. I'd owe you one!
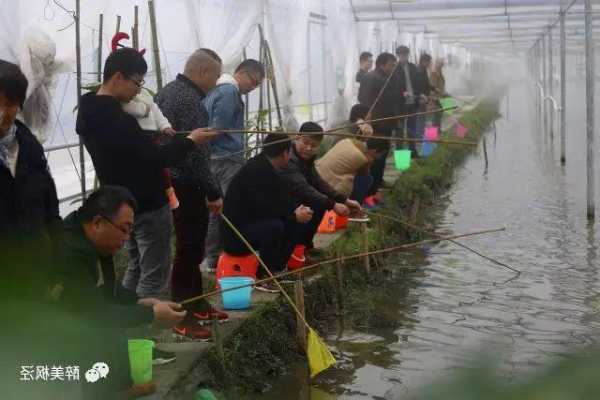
[171,182,209,311]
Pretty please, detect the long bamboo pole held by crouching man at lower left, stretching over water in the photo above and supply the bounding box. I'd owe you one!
[180,228,506,305]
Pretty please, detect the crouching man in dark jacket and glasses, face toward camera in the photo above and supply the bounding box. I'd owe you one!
[279,122,360,255]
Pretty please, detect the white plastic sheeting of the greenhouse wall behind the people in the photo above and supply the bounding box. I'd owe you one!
[0,0,482,206]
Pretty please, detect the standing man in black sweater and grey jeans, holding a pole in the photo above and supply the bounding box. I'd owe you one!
[77,48,215,297]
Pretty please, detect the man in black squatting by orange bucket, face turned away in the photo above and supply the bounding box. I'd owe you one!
[223,135,313,292]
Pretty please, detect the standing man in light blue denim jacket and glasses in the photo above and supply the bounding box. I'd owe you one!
[204,59,265,270]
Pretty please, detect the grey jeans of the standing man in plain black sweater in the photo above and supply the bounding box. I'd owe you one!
[123,204,173,297]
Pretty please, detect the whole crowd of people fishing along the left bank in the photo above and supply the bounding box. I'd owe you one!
[0,42,445,398]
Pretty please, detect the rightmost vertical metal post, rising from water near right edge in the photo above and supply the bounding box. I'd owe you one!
[585,0,596,220]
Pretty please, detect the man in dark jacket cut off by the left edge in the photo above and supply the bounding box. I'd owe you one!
[0,60,60,245]
